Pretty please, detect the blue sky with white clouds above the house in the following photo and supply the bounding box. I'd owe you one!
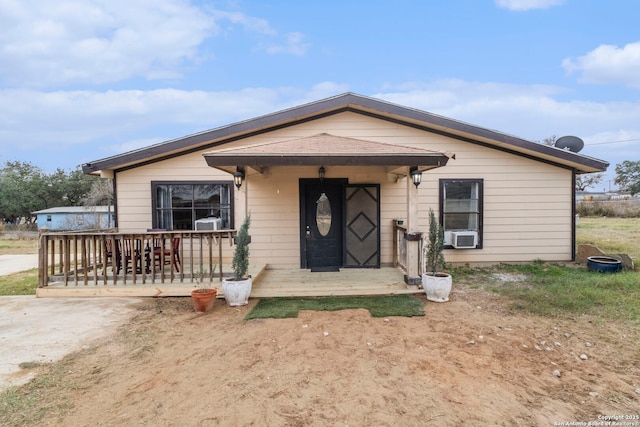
[0,0,640,190]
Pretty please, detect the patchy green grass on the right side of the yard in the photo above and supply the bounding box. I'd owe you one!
[460,217,640,324]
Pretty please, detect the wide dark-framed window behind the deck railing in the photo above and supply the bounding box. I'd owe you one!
[151,181,233,230]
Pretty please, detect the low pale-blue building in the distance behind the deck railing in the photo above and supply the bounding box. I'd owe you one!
[32,206,115,231]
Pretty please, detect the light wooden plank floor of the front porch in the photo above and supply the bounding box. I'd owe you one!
[36,266,423,298]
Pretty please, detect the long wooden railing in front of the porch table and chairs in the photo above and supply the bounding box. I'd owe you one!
[38,230,236,287]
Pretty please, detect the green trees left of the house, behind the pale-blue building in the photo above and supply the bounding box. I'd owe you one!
[0,161,113,224]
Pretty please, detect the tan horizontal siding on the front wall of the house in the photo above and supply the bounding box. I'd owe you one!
[111,113,572,268]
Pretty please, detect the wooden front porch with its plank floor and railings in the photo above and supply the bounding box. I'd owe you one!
[36,226,422,298]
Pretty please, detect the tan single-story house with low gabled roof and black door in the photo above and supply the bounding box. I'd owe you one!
[83,93,608,283]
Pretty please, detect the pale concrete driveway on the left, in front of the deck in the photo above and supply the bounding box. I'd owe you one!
[0,255,142,391]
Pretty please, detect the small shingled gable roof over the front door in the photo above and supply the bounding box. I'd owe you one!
[203,133,454,175]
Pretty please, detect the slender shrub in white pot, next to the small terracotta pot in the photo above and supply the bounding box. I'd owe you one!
[222,214,251,307]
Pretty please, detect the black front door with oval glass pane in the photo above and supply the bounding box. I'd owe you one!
[300,179,346,271]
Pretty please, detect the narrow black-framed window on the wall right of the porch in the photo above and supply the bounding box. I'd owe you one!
[440,179,483,248]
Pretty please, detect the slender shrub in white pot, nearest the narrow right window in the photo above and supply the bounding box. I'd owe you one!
[422,208,451,302]
